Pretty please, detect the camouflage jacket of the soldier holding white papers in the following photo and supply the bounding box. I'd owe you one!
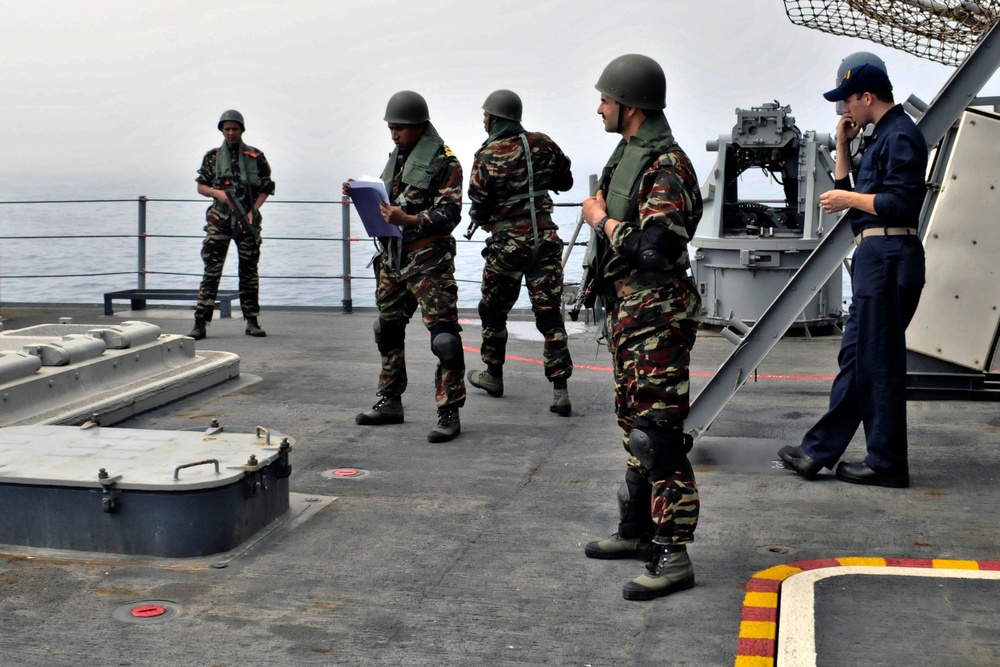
[388,146,462,245]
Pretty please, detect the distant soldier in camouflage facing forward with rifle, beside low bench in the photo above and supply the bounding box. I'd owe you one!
[188,109,274,340]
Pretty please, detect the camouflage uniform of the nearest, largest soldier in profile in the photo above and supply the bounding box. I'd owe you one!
[600,115,702,545]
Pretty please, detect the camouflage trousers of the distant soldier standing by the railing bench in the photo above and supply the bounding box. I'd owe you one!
[194,216,260,322]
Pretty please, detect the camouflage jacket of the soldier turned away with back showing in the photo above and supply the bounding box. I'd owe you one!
[469,119,573,231]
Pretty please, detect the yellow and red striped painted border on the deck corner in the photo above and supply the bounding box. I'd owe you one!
[735,557,1000,667]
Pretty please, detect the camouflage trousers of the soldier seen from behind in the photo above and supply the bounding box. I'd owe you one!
[479,229,573,382]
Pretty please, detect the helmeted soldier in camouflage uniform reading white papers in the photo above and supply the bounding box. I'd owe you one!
[344,90,465,442]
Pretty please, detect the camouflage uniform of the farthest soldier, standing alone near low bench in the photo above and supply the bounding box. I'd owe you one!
[195,143,274,322]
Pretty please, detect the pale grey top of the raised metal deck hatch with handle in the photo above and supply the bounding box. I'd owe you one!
[0,425,293,491]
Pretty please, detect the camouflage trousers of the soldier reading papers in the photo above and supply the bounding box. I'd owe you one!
[375,245,466,408]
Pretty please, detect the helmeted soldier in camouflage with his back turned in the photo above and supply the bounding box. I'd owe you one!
[467,90,573,416]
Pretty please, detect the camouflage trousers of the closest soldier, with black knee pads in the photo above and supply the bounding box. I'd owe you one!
[607,279,701,544]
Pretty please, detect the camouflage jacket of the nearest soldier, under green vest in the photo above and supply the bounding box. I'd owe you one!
[602,114,702,289]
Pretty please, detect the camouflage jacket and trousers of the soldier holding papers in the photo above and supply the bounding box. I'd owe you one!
[375,122,466,409]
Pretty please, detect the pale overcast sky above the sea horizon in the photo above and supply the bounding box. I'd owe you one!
[0,0,1000,201]
